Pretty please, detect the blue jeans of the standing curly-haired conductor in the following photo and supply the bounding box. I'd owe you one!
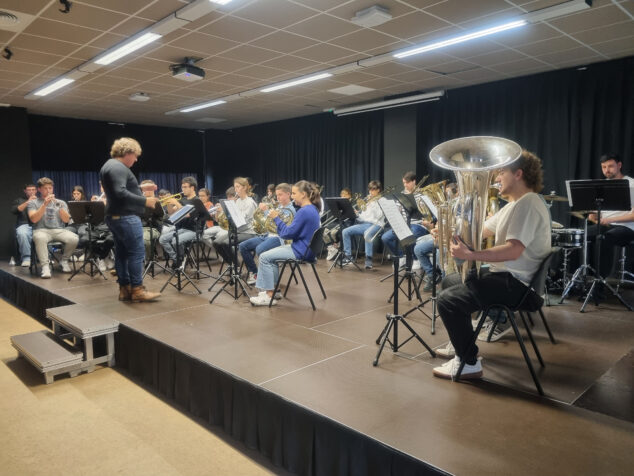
[106,215,145,287]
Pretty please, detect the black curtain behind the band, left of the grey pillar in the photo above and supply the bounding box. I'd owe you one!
[207,112,383,196]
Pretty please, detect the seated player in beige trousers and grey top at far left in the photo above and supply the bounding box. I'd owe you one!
[27,177,79,279]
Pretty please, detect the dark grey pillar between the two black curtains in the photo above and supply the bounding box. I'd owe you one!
[383,106,416,191]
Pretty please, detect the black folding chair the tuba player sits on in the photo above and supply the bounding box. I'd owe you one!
[455,248,559,395]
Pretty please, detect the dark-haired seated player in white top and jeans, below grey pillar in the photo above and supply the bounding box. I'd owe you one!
[342,180,385,269]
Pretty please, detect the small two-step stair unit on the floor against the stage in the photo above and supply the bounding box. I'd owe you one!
[11,304,119,384]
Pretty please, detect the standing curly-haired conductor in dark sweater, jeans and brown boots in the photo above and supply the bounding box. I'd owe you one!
[99,137,161,302]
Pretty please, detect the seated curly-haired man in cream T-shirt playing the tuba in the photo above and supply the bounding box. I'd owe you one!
[434,150,550,379]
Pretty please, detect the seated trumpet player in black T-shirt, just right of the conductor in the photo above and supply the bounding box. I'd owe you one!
[159,177,198,268]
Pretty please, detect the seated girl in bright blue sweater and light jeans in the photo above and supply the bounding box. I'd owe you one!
[251,180,321,306]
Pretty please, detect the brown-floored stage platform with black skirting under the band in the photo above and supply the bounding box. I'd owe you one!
[0,261,634,476]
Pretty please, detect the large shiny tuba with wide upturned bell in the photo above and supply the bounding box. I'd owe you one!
[429,136,522,281]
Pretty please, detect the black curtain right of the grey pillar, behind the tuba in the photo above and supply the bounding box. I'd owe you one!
[417,57,634,223]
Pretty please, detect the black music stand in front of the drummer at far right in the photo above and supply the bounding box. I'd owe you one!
[566,179,634,312]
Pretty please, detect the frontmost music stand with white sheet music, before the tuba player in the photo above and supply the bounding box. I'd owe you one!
[372,199,436,367]
